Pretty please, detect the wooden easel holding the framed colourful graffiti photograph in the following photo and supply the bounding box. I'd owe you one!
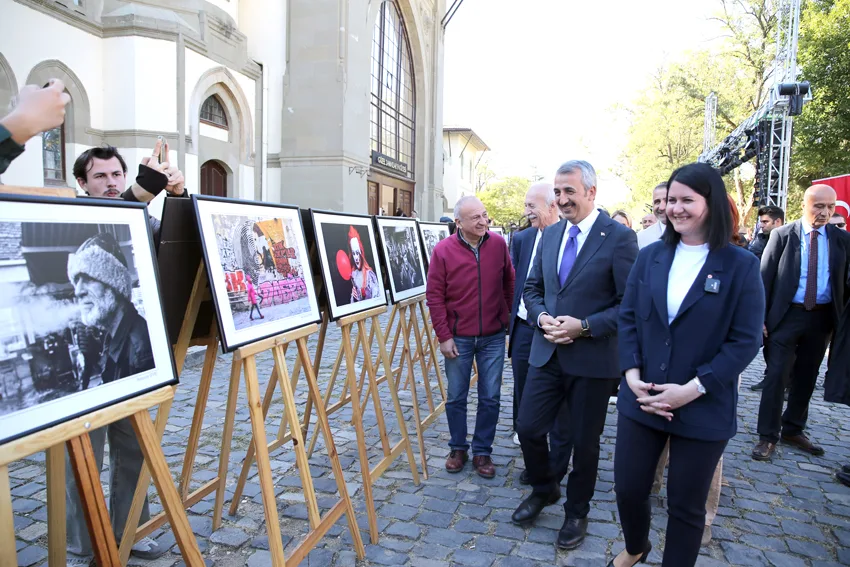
[216,324,366,567]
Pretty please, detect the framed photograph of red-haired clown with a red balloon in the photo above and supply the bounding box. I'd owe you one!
[311,211,387,321]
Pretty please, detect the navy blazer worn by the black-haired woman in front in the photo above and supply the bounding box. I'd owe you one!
[617,242,764,441]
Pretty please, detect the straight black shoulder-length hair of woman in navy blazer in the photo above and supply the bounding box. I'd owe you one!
[661,163,732,250]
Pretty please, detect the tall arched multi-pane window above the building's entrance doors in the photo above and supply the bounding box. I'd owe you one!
[370,0,416,179]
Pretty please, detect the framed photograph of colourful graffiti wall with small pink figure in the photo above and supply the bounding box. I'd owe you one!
[192,195,321,352]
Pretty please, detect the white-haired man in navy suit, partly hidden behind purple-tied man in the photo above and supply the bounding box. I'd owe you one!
[508,182,572,484]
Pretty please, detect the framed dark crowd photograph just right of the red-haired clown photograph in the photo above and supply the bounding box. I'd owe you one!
[375,217,426,303]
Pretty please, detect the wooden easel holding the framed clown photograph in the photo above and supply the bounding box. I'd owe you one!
[334,306,419,544]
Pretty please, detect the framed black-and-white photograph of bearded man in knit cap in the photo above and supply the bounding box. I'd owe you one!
[0,195,177,444]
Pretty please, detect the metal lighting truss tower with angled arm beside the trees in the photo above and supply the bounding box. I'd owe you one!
[699,0,811,210]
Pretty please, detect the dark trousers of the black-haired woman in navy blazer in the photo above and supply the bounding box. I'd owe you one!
[614,414,728,567]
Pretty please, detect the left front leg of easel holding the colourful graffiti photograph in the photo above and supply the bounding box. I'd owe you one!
[243,356,286,567]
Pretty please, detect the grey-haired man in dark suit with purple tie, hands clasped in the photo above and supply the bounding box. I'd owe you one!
[512,161,638,549]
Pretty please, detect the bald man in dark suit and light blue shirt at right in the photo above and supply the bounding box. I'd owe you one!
[752,185,850,461]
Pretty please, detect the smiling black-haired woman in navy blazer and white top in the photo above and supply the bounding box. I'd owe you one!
[609,163,764,567]
